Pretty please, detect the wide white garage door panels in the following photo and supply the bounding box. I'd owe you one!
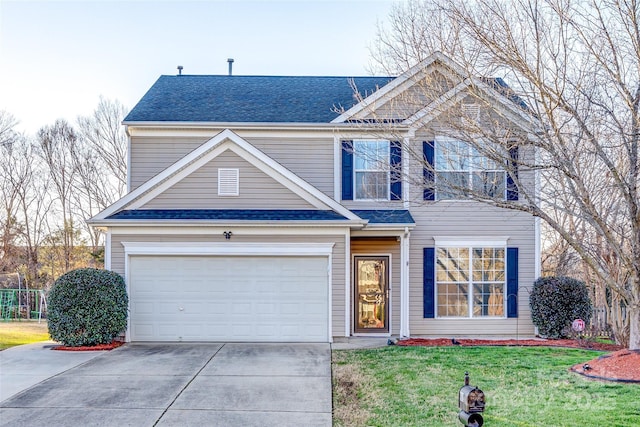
[129,255,329,342]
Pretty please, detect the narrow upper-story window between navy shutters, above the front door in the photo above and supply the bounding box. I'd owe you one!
[353,141,390,200]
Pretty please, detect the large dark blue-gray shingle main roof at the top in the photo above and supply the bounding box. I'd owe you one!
[124,75,393,123]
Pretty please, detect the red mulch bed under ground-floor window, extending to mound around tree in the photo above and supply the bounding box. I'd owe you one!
[397,338,640,383]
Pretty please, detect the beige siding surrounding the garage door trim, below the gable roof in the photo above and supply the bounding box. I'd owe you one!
[111,228,345,342]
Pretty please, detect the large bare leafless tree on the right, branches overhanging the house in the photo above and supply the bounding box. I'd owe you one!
[374,0,640,349]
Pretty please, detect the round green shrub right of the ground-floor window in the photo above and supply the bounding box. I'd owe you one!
[529,276,592,338]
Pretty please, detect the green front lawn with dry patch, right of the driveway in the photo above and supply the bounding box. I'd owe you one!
[333,347,640,427]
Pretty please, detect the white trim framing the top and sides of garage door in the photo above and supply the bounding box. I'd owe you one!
[122,242,334,342]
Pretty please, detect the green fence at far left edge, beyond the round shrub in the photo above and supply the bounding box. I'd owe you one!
[0,289,47,321]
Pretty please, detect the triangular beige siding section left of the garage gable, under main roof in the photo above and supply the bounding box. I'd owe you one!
[129,136,210,190]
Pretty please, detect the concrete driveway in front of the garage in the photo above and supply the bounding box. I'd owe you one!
[0,343,331,426]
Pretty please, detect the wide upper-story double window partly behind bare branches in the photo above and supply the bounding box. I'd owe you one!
[434,138,507,200]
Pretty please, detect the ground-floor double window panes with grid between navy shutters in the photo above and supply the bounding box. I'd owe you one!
[435,246,507,317]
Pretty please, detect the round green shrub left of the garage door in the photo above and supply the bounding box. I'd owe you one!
[47,268,128,347]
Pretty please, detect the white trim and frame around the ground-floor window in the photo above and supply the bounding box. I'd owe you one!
[434,241,509,320]
